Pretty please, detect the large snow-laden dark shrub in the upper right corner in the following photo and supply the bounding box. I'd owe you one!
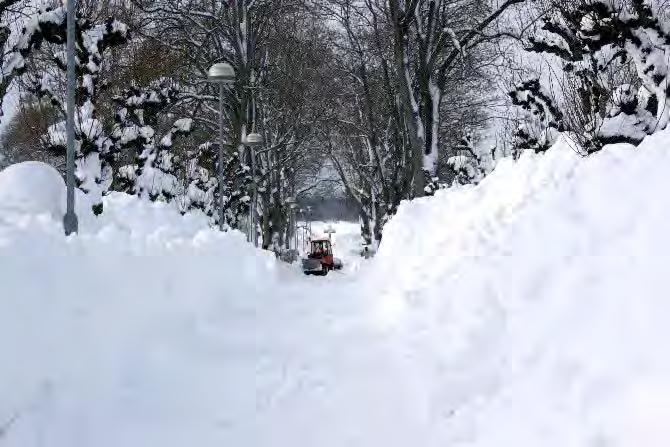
[527,0,670,153]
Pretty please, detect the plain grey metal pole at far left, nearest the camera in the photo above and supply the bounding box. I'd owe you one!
[63,0,79,235]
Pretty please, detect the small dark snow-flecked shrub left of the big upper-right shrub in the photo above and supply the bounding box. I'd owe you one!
[509,78,563,158]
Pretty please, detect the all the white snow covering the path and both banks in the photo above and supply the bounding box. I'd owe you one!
[0,132,670,447]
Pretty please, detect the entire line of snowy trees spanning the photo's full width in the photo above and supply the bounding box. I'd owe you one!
[0,0,670,252]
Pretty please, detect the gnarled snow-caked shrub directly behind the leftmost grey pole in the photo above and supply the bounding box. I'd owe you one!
[2,6,128,214]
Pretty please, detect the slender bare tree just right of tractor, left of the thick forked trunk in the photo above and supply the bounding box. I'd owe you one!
[322,0,412,244]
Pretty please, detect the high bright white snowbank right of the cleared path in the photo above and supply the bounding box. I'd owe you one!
[374,132,670,447]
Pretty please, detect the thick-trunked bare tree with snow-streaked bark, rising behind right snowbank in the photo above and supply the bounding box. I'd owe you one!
[386,0,525,196]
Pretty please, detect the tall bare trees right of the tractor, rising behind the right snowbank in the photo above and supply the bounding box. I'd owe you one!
[321,0,524,244]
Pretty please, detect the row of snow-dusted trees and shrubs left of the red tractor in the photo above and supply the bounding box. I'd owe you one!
[0,0,329,247]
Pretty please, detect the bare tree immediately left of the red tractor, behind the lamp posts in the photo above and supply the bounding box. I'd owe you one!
[254,10,333,249]
